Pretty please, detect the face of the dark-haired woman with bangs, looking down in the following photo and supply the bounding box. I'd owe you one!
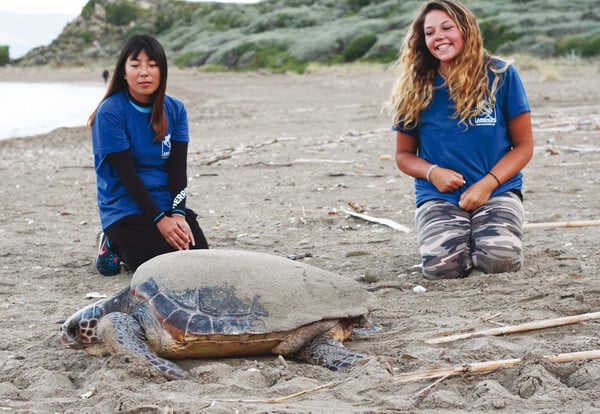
[125,50,160,103]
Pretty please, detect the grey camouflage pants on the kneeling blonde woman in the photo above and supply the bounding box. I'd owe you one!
[415,192,524,279]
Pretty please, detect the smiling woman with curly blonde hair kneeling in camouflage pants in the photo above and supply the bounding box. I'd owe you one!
[387,0,533,280]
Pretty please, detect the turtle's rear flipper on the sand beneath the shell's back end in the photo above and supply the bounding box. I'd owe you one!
[296,335,364,371]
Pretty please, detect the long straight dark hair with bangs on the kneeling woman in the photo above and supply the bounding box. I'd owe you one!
[88,34,168,140]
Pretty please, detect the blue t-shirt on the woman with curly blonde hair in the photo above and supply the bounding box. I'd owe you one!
[392,60,530,205]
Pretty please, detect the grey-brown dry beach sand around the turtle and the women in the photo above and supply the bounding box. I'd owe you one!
[0,61,600,413]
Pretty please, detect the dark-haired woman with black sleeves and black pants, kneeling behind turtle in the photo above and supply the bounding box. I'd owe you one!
[88,35,208,276]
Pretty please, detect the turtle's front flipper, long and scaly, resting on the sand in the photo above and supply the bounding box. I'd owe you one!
[98,312,188,379]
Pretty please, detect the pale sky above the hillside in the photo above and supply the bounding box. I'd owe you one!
[0,0,260,59]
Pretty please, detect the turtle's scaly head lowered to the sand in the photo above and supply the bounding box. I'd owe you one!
[60,301,106,349]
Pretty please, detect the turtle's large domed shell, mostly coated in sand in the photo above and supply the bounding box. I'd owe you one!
[131,249,377,357]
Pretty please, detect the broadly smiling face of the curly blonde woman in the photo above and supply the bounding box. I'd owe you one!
[423,9,464,75]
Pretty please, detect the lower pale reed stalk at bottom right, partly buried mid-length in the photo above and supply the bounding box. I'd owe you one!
[396,349,600,382]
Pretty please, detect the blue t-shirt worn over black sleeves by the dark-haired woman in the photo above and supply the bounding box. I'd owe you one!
[92,92,189,229]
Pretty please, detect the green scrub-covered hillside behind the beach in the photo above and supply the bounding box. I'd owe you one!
[15,0,600,72]
